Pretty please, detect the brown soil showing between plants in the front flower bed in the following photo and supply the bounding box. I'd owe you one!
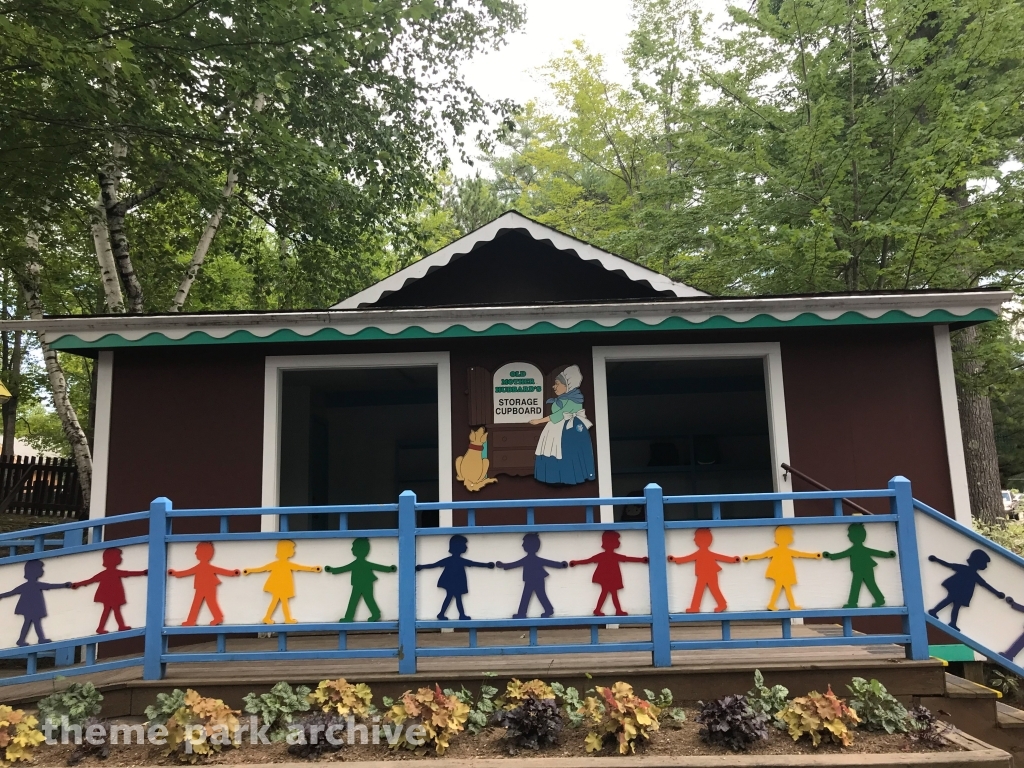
[33,709,962,768]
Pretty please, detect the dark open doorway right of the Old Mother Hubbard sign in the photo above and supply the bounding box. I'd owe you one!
[605,357,775,520]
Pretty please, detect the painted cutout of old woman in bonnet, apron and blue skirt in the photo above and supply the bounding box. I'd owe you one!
[530,366,595,485]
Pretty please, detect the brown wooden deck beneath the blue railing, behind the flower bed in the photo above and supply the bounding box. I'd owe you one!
[0,623,944,715]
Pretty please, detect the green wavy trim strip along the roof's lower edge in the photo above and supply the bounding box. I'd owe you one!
[50,309,998,350]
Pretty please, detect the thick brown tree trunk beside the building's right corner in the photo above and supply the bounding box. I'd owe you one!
[952,326,1005,523]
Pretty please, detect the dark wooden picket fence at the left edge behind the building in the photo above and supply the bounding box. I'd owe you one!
[0,456,85,519]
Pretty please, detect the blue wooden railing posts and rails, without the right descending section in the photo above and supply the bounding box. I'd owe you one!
[0,477,928,684]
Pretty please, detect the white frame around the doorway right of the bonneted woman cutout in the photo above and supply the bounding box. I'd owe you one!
[594,341,794,522]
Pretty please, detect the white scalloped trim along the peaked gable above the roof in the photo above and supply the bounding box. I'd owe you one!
[332,211,708,309]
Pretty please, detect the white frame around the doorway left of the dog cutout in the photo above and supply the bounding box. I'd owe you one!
[260,352,453,530]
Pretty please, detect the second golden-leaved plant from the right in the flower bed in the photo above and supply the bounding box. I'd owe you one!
[581,683,662,755]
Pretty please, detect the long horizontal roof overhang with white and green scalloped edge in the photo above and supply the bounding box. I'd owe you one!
[0,291,1013,351]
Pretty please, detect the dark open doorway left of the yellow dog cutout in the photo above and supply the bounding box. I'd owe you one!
[280,366,439,530]
